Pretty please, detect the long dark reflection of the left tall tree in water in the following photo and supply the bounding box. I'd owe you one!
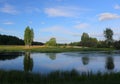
[24,52,33,72]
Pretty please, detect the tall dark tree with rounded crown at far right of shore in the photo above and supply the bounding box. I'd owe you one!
[104,28,113,47]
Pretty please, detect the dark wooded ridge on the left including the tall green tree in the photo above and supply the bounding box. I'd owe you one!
[0,26,44,46]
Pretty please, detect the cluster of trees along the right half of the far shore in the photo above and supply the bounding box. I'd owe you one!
[69,28,120,49]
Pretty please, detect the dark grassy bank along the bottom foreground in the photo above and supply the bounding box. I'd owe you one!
[0,70,120,84]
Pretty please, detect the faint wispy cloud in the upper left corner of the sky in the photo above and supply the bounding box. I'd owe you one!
[0,4,18,15]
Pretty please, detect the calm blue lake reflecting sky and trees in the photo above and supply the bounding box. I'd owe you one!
[0,51,120,74]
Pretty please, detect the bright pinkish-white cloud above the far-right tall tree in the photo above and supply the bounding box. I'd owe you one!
[99,13,120,21]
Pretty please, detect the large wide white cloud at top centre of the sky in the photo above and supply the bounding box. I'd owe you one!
[44,6,80,17]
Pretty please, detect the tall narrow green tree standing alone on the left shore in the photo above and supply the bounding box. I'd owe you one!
[24,26,34,46]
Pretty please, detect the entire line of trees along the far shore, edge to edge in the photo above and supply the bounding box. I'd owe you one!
[0,26,120,49]
